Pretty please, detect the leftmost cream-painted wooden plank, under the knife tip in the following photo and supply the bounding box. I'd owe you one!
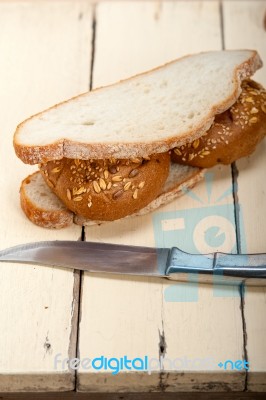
[0,1,92,392]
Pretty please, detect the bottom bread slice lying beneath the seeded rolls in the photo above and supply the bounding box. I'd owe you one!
[20,163,204,229]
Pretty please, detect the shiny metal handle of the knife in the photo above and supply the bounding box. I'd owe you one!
[165,247,266,286]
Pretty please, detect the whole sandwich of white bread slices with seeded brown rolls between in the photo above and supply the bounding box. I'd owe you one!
[13,50,266,228]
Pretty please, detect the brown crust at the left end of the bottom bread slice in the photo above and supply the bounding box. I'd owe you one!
[20,171,74,229]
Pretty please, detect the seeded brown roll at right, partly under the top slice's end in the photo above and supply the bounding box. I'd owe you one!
[171,80,266,168]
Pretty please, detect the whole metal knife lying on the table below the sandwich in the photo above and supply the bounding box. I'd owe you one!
[0,241,266,286]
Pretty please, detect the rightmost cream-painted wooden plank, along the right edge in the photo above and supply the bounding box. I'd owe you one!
[223,1,266,391]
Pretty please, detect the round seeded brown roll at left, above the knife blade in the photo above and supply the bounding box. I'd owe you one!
[40,152,170,221]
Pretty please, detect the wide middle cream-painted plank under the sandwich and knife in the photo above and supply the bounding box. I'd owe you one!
[78,1,245,392]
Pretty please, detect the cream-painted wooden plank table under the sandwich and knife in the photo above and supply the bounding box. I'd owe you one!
[0,0,266,392]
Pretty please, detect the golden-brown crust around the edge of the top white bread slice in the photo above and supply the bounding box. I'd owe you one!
[13,51,262,164]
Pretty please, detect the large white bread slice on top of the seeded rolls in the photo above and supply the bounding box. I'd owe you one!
[14,50,262,164]
